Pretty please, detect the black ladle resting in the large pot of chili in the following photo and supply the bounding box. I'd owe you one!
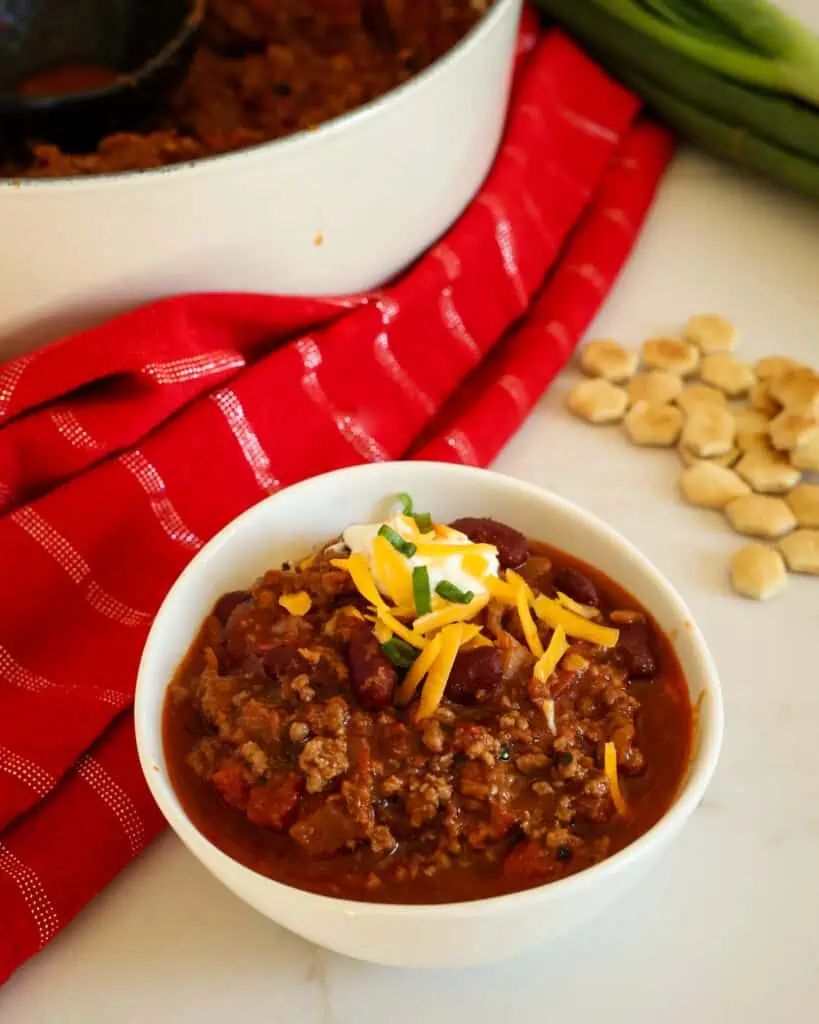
[0,0,206,153]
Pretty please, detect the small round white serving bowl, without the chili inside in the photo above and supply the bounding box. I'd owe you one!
[135,462,723,967]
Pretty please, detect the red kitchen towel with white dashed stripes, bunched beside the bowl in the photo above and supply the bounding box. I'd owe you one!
[0,25,672,981]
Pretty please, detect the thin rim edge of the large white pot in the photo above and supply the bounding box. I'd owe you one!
[0,0,522,196]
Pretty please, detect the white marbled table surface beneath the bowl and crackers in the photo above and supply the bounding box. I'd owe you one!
[0,140,819,1024]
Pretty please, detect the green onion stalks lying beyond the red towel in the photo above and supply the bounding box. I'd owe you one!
[535,0,819,198]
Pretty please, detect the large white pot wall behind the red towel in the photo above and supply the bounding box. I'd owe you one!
[0,0,521,357]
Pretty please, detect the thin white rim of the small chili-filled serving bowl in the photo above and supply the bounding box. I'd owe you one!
[134,461,725,920]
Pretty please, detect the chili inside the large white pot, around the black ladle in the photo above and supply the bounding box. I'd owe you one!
[0,0,489,177]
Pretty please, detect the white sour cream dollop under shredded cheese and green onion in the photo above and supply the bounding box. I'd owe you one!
[343,515,500,597]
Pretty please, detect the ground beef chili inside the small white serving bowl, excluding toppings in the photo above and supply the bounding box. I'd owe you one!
[166,542,690,902]
